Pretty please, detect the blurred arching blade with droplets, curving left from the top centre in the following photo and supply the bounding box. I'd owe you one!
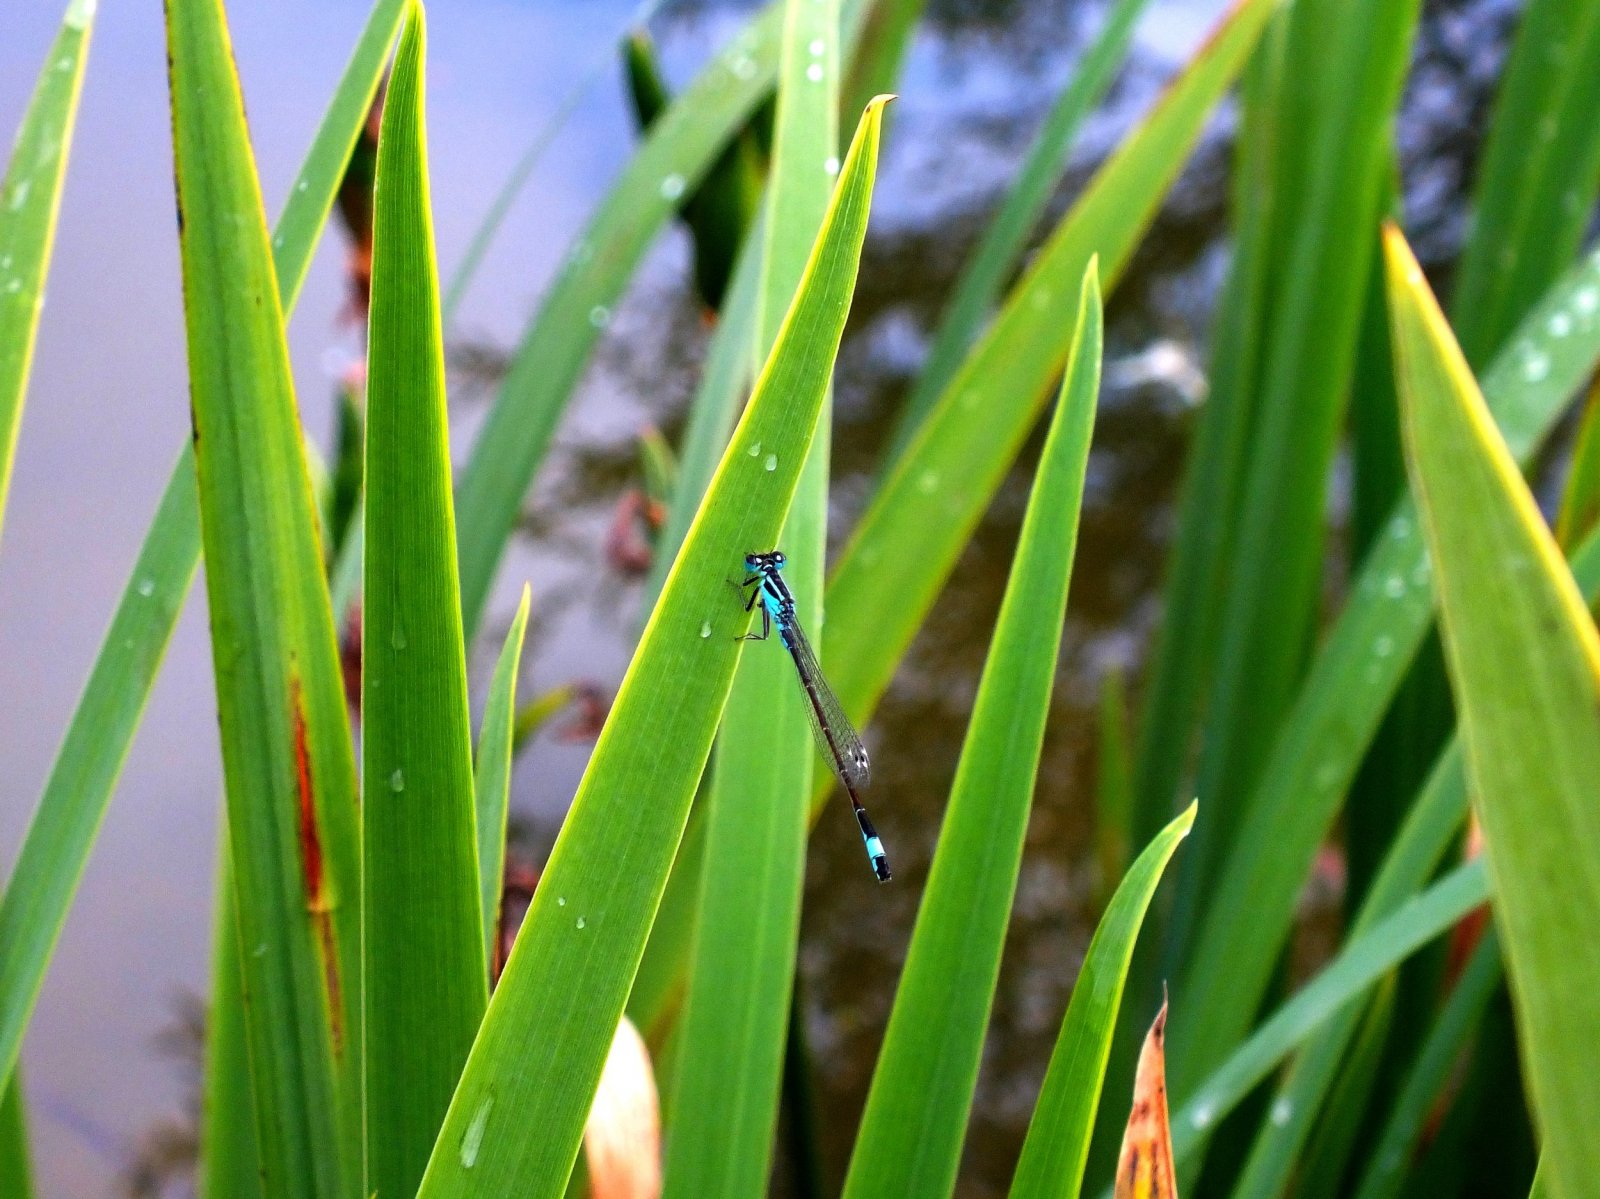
[456,6,782,639]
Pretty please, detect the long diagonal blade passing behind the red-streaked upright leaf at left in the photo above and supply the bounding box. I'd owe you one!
[0,0,403,1094]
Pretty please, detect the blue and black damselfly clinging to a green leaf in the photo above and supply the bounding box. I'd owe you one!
[739,549,890,882]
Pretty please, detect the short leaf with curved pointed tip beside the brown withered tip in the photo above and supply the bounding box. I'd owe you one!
[1011,804,1195,1199]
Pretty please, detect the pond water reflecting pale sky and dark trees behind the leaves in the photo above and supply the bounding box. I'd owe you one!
[0,0,1510,1196]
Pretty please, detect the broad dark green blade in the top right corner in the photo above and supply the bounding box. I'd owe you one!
[1450,0,1600,367]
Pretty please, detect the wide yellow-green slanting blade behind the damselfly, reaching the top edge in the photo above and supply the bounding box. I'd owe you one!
[814,0,1275,768]
